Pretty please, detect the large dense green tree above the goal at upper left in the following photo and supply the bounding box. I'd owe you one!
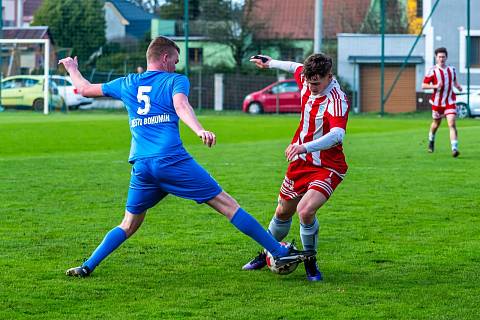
[32,0,106,62]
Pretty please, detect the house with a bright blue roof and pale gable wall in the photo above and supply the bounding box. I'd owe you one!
[103,0,156,41]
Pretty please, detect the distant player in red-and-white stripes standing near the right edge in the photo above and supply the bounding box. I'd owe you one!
[422,47,462,157]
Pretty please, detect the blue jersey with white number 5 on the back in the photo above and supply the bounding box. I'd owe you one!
[102,71,190,163]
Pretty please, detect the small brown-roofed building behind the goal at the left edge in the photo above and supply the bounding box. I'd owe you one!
[2,26,56,76]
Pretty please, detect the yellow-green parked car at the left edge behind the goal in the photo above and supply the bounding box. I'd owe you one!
[1,75,65,111]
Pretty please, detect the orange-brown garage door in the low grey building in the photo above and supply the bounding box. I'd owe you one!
[360,64,416,113]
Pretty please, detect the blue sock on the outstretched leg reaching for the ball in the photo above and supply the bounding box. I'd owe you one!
[230,208,288,256]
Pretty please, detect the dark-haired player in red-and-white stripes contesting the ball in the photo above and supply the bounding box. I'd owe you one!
[243,54,349,281]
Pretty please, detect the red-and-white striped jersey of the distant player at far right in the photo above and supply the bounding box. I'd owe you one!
[423,65,457,107]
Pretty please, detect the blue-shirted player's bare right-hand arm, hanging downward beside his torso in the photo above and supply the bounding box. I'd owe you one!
[173,93,217,147]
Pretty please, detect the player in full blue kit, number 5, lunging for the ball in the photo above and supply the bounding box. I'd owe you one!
[59,37,314,277]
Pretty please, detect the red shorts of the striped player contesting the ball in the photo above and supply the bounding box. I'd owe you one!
[280,160,342,200]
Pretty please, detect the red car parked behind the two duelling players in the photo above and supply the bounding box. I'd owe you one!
[242,79,301,114]
